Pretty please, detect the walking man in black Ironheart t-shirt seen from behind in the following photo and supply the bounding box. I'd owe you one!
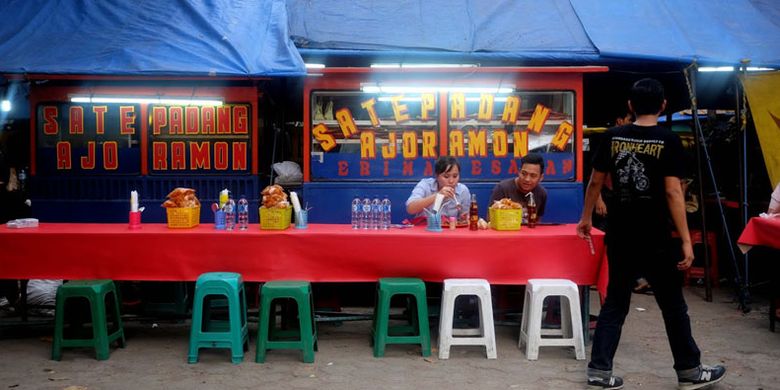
[577,79,726,389]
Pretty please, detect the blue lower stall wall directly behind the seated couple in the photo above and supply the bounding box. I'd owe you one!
[302,182,583,223]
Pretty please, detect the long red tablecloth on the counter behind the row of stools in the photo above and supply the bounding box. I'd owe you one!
[0,223,604,287]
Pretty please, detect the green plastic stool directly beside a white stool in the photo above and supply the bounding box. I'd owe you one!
[371,278,431,357]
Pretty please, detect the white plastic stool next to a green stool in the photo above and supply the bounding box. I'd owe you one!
[439,279,497,359]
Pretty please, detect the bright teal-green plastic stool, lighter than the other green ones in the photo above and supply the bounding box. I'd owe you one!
[187,272,249,364]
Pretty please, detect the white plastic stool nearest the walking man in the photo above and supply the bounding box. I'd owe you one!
[517,279,585,360]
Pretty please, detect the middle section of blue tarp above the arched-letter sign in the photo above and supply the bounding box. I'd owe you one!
[288,0,597,55]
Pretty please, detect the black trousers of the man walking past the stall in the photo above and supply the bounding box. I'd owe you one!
[588,239,701,371]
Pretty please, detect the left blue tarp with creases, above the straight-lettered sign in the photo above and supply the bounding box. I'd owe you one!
[0,0,306,77]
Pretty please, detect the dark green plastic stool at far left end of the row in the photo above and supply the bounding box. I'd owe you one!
[51,280,125,360]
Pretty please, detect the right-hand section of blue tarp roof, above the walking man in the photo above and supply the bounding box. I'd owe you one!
[571,0,780,67]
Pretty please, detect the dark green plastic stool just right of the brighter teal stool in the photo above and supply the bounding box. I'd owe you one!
[255,281,317,363]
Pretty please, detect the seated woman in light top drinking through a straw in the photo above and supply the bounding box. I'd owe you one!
[406,157,471,219]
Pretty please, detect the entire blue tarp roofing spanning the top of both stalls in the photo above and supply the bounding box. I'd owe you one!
[0,0,780,77]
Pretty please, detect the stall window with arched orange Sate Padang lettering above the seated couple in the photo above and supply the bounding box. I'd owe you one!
[311,91,575,180]
